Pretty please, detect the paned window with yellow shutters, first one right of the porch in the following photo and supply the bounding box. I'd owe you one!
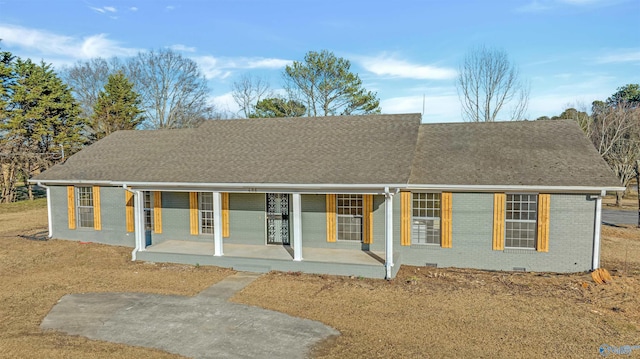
[411,193,440,244]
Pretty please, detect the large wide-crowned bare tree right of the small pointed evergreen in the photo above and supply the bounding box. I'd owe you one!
[126,49,214,129]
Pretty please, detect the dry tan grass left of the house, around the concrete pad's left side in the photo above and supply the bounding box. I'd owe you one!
[0,206,232,358]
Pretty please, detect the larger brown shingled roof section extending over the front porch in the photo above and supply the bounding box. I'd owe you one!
[36,114,420,184]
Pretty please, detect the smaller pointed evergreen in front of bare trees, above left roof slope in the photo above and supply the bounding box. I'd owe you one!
[91,72,144,140]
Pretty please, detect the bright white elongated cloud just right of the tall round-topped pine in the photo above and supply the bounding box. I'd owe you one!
[358,55,457,80]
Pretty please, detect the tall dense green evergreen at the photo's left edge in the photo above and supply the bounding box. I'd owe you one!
[0,58,85,202]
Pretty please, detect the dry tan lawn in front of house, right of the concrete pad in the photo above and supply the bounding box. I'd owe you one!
[234,227,640,358]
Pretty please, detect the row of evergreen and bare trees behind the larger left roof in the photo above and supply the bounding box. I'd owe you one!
[0,45,380,203]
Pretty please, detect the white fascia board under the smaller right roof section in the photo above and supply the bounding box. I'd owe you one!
[405,184,625,193]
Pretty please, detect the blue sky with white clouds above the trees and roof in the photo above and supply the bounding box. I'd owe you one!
[0,0,640,122]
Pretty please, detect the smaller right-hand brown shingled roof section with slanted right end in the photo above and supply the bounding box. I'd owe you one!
[409,120,620,187]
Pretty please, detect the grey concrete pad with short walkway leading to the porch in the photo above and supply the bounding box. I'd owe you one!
[41,273,340,358]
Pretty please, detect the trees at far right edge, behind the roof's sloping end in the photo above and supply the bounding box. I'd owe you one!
[538,84,640,205]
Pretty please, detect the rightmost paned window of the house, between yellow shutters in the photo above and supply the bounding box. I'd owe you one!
[504,194,538,249]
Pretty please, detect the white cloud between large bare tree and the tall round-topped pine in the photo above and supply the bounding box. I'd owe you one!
[193,56,291,79]
